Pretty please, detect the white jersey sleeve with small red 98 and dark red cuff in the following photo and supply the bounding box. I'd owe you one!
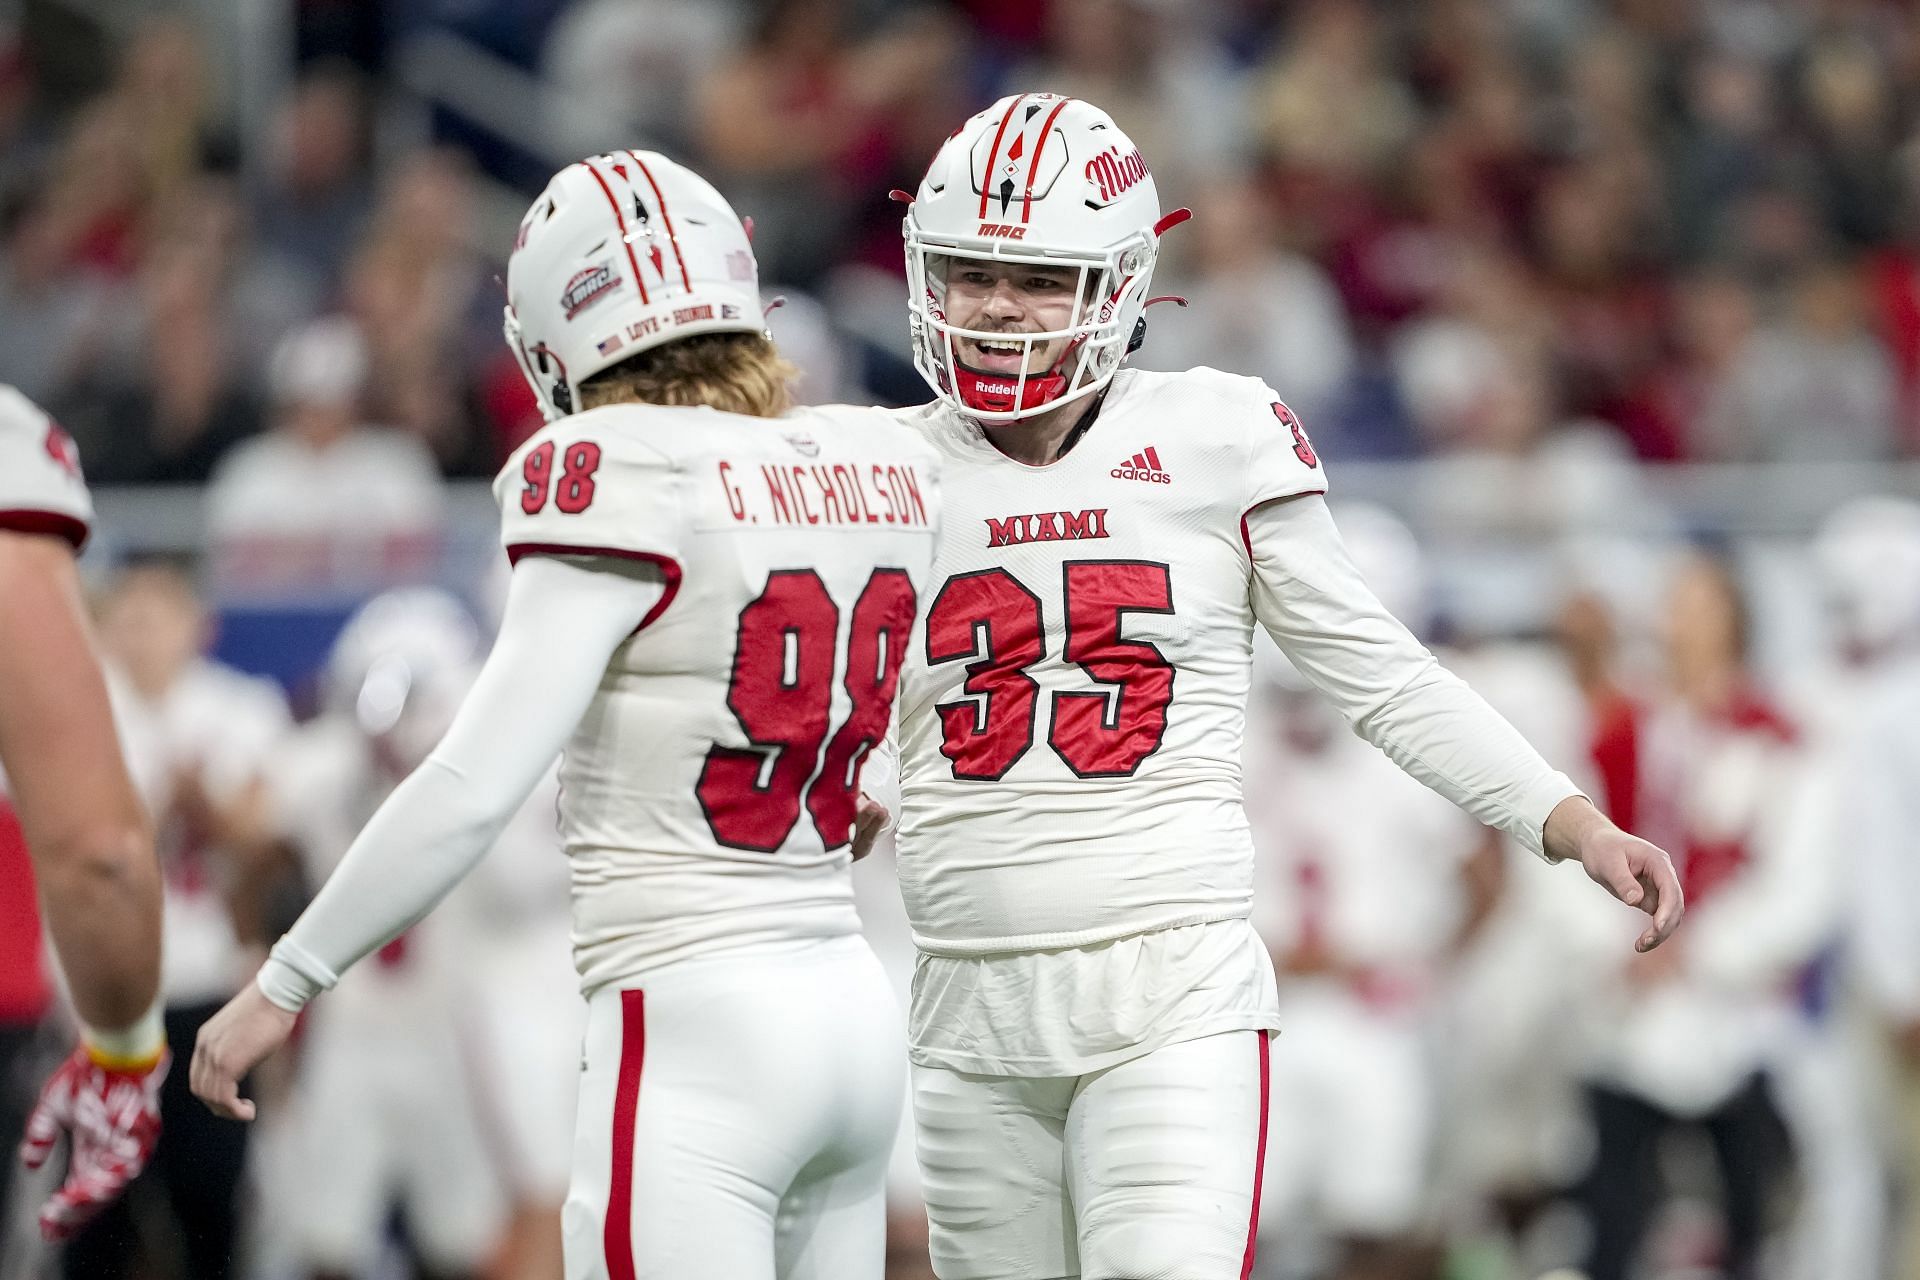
[493,415,684,578]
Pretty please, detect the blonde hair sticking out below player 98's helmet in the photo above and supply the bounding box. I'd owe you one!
[580,334,801,418]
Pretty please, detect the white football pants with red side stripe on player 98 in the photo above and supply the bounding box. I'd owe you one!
[563,936,906,1280]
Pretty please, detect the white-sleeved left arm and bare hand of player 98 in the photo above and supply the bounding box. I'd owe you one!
[192,557,664,1121]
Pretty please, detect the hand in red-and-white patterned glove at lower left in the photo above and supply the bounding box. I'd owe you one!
[19,1044,169,1240]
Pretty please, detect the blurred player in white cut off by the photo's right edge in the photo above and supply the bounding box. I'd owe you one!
[1788,495,1920,1278]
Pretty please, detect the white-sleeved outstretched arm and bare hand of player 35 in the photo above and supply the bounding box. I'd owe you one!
[1246,495,1682,950]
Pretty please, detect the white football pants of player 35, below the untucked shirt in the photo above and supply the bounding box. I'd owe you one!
[914,1031,1267,1280]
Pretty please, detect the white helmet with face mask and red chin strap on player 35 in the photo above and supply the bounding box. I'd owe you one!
[897,94,1188,422]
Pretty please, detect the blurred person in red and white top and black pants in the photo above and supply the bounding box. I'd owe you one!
[1580,555,1837,1280]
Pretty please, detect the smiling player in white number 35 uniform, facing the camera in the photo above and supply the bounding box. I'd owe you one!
[876,94,1680,1280]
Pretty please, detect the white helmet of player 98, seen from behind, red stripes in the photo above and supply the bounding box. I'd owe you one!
[505,152,766,422]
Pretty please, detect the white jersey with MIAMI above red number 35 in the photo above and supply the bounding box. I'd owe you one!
[899,368,1327,956]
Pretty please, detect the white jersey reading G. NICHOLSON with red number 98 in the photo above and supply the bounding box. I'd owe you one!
[495,405,939,992]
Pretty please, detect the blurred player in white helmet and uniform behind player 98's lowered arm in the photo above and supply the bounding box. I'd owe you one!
[269,587,514,1280]
